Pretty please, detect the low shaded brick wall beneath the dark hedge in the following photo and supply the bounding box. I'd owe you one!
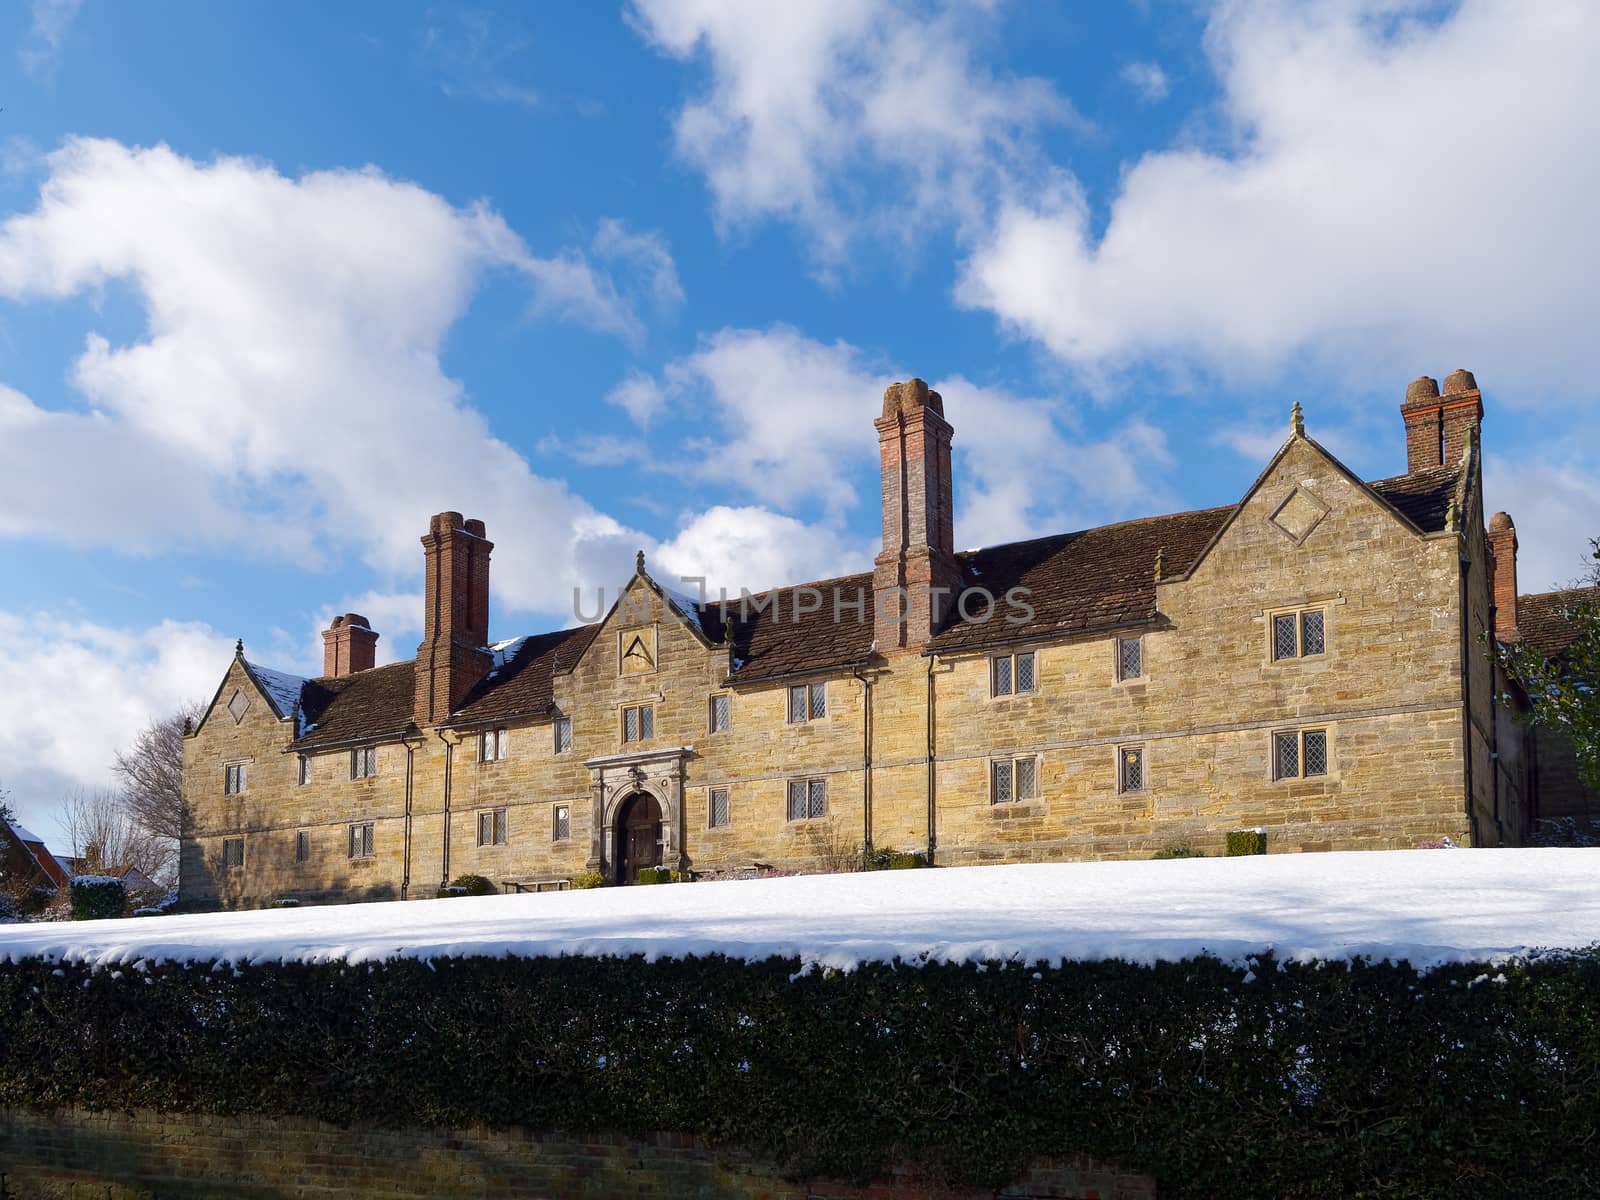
[0,1110,1155,1200]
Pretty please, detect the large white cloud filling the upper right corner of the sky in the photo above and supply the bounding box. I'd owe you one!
[957,0,1600,390]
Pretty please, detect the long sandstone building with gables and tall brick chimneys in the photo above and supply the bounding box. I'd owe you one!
[181,371,1587,906]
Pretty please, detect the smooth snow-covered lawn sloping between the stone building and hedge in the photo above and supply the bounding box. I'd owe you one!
[0,850,1600,968]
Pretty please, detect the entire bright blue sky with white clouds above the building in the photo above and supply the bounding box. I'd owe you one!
[0,0,1600,832]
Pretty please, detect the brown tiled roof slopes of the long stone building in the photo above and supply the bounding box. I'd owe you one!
[259,464,1465,749]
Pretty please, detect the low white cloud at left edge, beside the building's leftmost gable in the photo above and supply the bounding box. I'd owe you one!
[0,611,234,838]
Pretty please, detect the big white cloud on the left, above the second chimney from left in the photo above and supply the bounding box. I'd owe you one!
[0,139,675,611]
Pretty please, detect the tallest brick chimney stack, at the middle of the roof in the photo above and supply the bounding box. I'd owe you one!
[872,379,962,653]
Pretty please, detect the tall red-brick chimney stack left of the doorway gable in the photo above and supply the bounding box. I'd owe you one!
[413,512,494,726]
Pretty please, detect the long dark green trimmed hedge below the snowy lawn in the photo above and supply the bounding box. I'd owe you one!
[0,952,1600,1200]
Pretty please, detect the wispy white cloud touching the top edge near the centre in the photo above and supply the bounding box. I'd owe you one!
[632,0,1078,264]
